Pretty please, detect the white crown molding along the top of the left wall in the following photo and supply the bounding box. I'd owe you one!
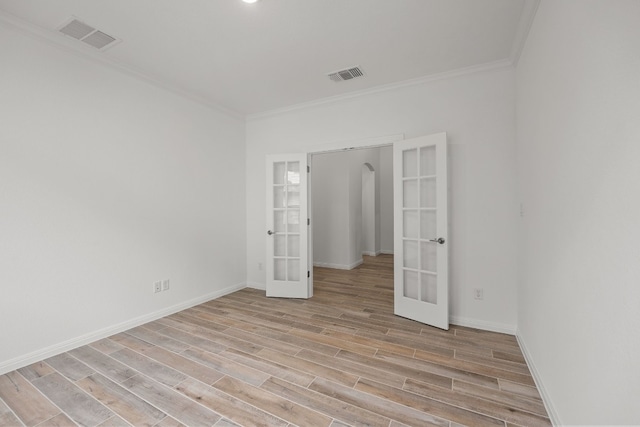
[0,10,245,121]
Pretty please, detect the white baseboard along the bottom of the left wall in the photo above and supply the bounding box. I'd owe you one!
[0,282,247,375]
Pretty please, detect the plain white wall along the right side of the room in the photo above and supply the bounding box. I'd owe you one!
[517,0,640,425]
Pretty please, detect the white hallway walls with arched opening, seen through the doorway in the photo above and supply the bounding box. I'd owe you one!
[310,144,393,270]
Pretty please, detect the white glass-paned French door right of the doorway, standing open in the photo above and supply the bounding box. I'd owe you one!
[393,133,449,329]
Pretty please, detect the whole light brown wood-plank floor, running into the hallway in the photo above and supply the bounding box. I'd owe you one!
[0,255,550,427]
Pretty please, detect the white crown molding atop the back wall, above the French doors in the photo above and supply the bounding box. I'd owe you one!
[246,59,513,122]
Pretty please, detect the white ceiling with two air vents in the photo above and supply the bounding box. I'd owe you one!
[0,0,539,117]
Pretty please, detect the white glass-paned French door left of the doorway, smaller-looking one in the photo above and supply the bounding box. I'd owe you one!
[265,154,311,298]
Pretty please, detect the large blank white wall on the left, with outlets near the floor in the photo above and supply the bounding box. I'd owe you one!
[0,24,246,372]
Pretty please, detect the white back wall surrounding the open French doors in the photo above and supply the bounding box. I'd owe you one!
[246,67,518,332]
